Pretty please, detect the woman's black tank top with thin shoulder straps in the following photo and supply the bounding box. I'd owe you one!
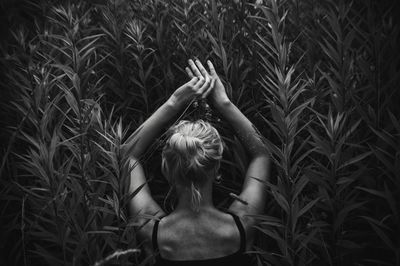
[152,212,255,266]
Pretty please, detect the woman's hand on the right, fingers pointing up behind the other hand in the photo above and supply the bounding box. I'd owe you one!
[186,59,230,107]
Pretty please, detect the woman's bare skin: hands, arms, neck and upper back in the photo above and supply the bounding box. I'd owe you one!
[125,60,269,260]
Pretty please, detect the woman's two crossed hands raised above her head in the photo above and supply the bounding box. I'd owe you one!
[170,59,229,107]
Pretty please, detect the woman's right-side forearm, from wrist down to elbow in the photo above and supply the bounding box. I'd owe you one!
[217,100,268,158]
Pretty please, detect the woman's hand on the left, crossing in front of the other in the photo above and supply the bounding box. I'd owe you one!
[169,76,214,108]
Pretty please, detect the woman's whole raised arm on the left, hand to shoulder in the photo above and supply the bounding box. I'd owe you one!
[123,74,213,222]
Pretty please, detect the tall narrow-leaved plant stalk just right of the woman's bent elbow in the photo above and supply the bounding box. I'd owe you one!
[252,1,319,265]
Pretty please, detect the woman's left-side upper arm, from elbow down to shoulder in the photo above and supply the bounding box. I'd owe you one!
[129,157,164,224]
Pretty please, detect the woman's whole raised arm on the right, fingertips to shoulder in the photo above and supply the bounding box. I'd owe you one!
[186,60,269,215]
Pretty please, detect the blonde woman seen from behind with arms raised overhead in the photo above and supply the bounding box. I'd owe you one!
[123,60,269,266]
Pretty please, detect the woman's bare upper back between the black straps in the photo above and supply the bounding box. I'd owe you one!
[153,211,245,259]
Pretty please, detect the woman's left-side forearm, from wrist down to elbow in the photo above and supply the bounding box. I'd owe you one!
[124,99,180,159]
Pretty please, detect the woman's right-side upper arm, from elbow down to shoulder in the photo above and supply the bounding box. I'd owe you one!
[229,154,270,216]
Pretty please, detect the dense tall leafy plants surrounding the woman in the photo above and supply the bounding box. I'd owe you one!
[0,0,400,265]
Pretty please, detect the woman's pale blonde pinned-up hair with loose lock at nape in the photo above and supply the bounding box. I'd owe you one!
[161,120,223,211]
